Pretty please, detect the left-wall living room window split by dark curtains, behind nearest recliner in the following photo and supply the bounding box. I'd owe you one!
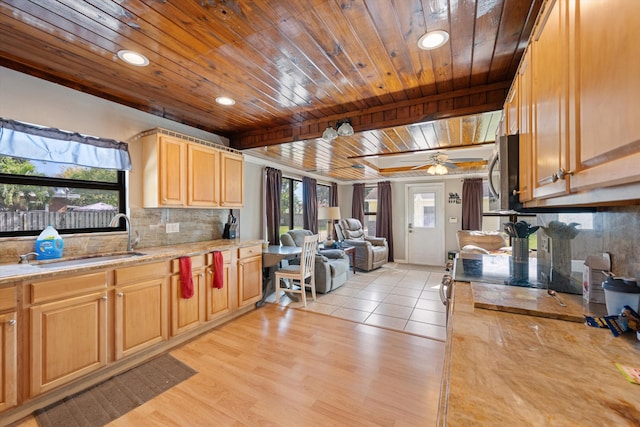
[280,177,331,239]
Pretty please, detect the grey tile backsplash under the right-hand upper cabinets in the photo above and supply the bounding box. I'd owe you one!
[537,205,640,293]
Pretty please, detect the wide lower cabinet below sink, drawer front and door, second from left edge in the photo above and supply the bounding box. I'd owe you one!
[29,272,108,396]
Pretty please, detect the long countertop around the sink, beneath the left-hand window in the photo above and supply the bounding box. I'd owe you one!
[0,239,262,287]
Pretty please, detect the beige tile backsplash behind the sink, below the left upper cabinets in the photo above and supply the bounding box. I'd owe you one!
[0,208,242,263]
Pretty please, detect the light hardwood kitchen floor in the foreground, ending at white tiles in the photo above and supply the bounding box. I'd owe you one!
[20,304,444,427]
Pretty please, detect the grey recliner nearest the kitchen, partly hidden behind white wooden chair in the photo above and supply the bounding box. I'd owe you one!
[280,230,351,294]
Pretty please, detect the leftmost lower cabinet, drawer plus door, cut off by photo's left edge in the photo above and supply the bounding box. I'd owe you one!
[0,287,18,412]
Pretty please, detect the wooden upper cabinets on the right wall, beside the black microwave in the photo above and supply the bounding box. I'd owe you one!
[504,0,640,207]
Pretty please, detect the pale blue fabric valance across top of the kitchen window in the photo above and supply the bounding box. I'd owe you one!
[0,118,131,170]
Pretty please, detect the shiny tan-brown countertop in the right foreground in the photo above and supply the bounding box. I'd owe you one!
[438,282,640,426]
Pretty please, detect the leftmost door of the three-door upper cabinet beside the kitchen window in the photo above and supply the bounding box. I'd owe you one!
[158,136,187,206]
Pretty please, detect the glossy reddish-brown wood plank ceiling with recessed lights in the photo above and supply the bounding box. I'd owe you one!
[0,0,543,180]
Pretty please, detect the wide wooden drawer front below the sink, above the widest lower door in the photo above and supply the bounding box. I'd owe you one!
[30,271,107,304]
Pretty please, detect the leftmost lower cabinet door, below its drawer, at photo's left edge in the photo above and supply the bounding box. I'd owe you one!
[0,312,18,412]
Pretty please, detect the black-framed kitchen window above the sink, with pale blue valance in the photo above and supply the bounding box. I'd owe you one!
[0,119,130,237]
